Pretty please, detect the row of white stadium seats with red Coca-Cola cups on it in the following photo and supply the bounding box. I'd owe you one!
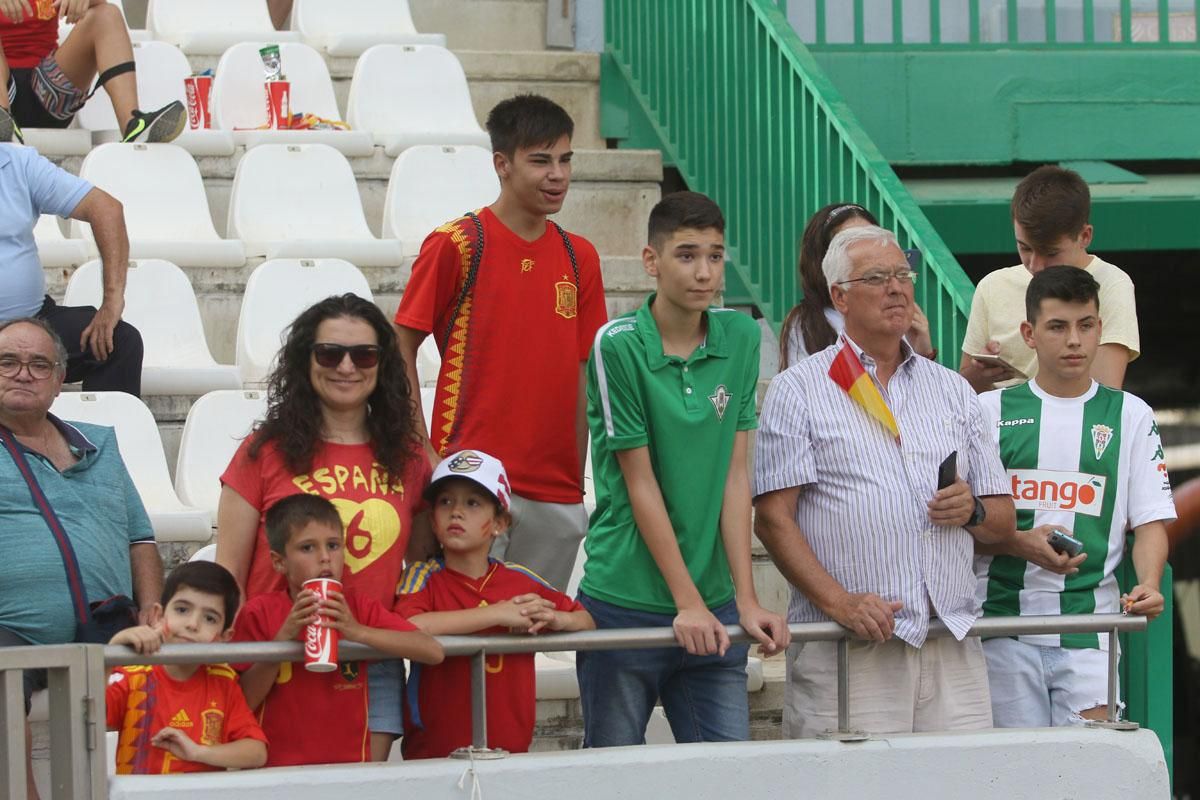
[25,41,488,156]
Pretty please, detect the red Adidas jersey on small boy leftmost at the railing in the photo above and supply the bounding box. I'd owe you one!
[104,664,270,775]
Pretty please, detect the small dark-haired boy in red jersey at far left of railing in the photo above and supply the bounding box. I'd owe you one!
[104,561,266,775]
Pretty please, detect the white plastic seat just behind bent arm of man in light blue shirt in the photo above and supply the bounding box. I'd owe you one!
[71,143,246,266]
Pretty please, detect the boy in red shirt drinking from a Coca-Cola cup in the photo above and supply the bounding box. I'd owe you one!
[234,494,442,766]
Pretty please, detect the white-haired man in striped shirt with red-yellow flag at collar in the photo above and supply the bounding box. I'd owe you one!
[754,225,1015,738]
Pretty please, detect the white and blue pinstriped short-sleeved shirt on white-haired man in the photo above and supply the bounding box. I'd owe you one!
[754,335,1009,646]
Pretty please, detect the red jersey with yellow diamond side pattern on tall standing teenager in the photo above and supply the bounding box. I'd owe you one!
[396,209,607,503]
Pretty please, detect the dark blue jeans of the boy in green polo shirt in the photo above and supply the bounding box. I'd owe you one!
[575,591,750,747]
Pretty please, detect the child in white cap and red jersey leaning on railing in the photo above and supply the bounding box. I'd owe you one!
[395,450,595,759]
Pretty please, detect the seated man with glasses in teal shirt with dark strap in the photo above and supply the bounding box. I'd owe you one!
[0,318,162,796]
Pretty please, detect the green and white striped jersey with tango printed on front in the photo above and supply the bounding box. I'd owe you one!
[976,380,1175,649]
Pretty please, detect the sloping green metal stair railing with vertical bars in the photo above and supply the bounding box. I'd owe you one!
[601,0,974,367]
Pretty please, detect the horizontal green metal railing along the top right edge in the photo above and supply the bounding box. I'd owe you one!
[778,0,1200,49]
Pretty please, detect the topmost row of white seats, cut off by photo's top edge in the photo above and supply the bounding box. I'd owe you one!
[82,0,446,56]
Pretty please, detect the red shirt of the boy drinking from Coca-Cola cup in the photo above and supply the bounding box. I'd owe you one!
[233,590,416,766]
